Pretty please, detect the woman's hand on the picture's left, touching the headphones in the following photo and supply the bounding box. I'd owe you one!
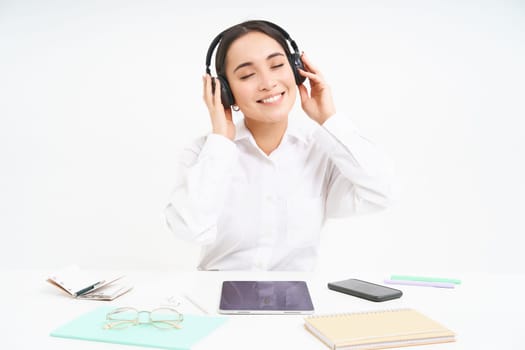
[202,74,235,141]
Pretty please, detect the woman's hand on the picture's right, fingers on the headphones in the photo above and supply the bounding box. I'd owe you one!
[299,53,335,124]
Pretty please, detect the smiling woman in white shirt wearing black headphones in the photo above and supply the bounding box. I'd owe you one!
[166,21,390,270]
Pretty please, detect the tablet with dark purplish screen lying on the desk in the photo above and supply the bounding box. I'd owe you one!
[219,281,314,314]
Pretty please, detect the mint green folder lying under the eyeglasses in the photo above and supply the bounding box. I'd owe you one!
[50,306,226,350]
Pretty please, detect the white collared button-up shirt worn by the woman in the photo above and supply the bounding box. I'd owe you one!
[166,115,391,270]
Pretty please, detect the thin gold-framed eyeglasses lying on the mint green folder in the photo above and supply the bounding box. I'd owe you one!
[104,307,184,329]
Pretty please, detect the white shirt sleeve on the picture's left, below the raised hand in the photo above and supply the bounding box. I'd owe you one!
[165,134,238,244]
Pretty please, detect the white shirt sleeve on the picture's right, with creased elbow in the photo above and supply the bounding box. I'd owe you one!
[314,114,393,217]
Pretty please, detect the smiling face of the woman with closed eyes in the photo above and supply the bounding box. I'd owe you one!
[226,32,297,123]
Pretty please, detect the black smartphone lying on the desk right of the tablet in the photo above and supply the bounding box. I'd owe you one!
[328,278,403,301]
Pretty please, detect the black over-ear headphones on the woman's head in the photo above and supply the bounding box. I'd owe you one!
[206,21,306,108]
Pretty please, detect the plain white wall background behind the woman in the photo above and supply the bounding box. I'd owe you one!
[0,0,525,277]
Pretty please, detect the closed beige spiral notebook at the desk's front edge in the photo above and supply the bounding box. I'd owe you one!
[305,309,456,349]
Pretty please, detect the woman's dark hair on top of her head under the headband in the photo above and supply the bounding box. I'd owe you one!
[215,20,290,78]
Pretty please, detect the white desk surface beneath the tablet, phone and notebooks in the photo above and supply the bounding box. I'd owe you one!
[0,270,525,350]
